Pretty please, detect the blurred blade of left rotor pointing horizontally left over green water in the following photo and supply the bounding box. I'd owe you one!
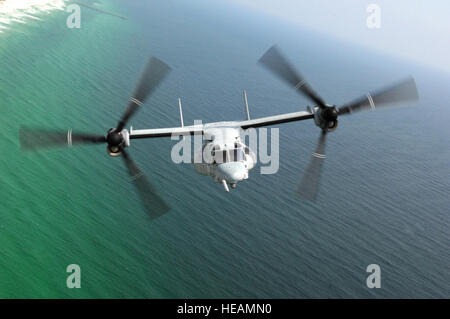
[19,127,106,151]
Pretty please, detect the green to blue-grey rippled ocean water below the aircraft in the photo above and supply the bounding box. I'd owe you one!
[0,0,450,298]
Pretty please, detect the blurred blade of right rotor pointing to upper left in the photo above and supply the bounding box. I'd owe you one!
[259,46,326,108]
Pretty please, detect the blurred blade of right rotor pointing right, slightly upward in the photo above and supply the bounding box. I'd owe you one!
[338,78,419,115]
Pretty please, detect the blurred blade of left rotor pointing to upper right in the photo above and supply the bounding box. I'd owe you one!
[117,57,170,132]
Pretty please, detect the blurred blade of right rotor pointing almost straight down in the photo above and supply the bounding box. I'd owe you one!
[298,131,327,202]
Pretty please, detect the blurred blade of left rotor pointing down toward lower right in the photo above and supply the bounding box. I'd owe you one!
[122,150,170,219]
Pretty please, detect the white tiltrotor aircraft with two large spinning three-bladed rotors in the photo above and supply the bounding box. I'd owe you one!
[19,46,418,218]
